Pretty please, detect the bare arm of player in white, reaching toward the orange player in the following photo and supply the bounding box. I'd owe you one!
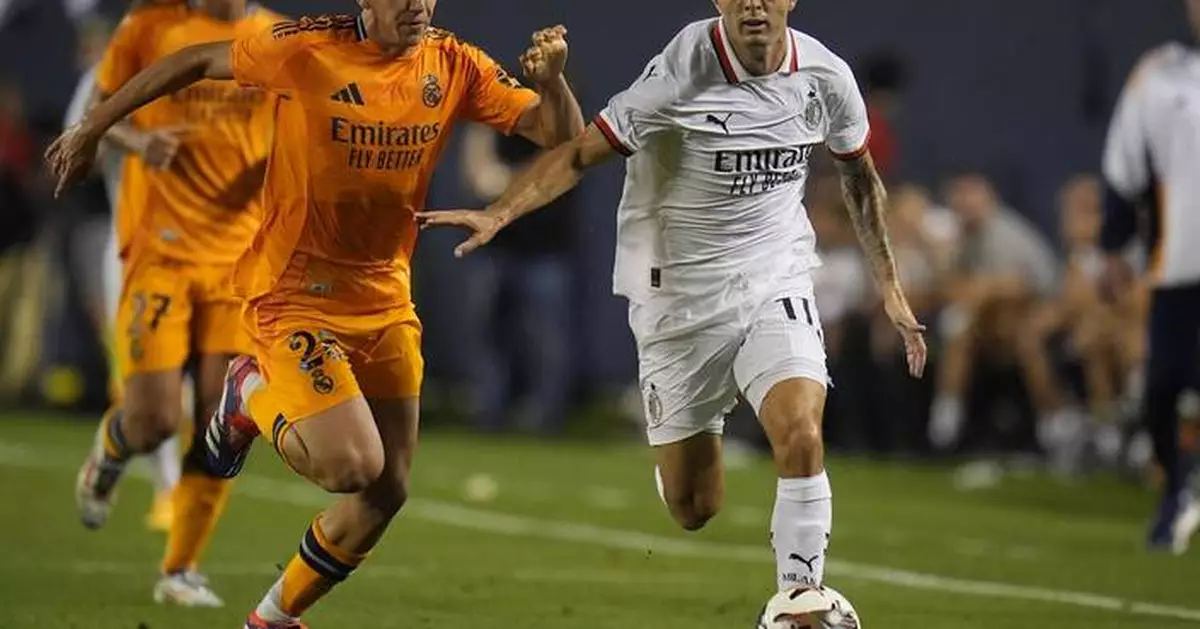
[416,124,616,258]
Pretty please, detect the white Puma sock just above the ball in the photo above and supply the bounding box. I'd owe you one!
[770,472,833,591]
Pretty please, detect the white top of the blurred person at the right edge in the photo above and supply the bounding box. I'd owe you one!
[1104,44,1200,287]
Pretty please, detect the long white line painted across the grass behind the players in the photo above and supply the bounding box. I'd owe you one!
[0,442,1200,622]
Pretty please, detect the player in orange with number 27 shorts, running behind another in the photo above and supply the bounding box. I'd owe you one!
[76,0,283,606]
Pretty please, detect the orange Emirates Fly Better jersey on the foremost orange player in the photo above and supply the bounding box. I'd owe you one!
[232,16,538,329]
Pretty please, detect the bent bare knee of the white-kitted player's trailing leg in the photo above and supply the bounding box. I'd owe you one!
[654,432,725,531]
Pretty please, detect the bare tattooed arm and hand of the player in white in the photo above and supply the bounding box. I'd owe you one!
[838,152,926,378]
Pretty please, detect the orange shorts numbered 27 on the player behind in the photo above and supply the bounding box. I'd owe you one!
[114,253,251,381]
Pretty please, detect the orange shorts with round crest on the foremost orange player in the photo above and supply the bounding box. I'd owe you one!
[245,302,425,433]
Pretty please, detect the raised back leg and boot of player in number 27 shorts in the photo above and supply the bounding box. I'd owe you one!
[76,370,182,529]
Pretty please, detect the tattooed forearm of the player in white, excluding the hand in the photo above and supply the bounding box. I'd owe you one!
[838,154,896,288]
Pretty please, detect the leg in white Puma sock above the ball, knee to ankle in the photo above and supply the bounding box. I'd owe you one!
[758,378,833,591]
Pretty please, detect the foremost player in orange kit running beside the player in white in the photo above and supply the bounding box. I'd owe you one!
[47,0,583,629]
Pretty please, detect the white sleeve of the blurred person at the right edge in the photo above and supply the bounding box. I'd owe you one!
[1103,66,1151,200]
